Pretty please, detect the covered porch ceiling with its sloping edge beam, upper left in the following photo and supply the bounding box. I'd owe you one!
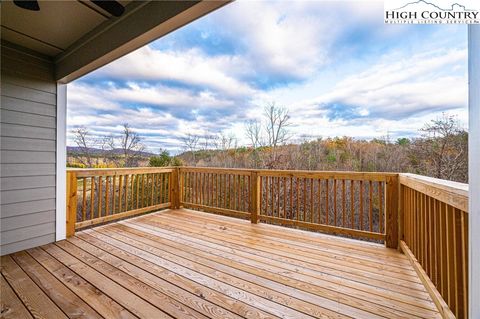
[1,0,229,83]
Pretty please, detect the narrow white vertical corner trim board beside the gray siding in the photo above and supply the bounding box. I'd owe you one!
[55,83,67,241]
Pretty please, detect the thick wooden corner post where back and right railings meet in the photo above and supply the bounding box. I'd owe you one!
[385,175,399,249]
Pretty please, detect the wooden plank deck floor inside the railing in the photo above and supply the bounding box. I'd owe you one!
[0,209,439,318]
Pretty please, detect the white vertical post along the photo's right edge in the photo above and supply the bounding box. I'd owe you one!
[468,24,480,319]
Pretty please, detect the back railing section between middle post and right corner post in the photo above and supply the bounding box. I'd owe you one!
[258,170,398,247]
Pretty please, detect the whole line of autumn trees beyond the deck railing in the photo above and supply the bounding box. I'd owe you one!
[69,103,468,183]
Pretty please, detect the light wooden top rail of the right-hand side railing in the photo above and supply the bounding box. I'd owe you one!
[399,173,468,213]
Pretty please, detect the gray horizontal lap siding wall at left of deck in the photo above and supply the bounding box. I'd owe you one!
[0,43,57,255]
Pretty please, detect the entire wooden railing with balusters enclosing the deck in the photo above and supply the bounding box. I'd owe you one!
[67,167,468,318]
